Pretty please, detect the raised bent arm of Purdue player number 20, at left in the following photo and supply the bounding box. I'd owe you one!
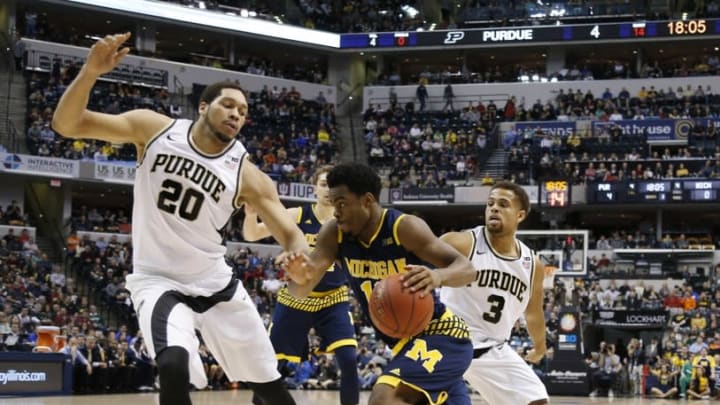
[52,33,172,147]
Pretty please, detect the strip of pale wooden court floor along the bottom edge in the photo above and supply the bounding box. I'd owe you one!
[0,390,719,405]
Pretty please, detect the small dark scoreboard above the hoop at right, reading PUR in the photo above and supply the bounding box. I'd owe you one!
[587,179,720,204]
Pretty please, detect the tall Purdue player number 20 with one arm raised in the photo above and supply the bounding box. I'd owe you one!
[52,33,309,405]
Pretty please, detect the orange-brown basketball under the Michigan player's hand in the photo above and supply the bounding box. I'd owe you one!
[368,274,434,339]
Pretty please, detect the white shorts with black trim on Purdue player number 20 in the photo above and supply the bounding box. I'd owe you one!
[127,274,280,388]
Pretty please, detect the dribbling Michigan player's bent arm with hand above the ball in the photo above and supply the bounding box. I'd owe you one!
[397,215,476,294]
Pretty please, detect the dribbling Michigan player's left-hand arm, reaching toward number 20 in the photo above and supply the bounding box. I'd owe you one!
[281,219,339,298]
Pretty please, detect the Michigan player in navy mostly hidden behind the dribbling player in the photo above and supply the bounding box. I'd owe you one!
[243,166,360,405]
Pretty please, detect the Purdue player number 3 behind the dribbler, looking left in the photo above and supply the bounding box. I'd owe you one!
[440,182,548,405]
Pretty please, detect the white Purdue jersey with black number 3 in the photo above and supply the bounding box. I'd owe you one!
[440,226,535,348]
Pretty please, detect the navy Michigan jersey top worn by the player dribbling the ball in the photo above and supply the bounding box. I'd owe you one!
[338,209,445,346]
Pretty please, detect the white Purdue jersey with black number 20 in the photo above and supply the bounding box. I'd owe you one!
[132,120,246,290]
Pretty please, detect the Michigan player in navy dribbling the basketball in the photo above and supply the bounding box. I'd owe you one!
[283,163,475,405]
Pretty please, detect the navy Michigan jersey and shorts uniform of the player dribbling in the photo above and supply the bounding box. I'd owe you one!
[337,209,473,405]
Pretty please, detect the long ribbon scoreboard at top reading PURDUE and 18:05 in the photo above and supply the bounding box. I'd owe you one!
[340,18,720,49]
